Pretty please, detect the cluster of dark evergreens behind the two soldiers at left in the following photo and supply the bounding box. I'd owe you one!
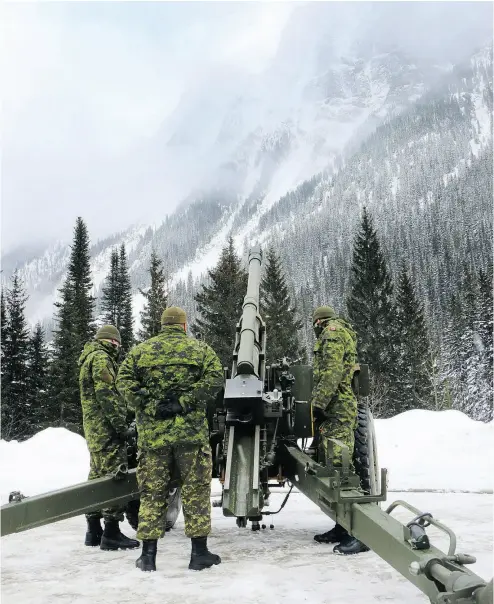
[1,218,167,440]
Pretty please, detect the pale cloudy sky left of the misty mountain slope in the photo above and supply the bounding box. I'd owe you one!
[0,2,295,251]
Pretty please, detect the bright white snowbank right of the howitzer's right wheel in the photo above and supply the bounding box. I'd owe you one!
[376,409,494,493]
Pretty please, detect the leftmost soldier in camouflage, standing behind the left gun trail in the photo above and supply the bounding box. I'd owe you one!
[79,325,139,550]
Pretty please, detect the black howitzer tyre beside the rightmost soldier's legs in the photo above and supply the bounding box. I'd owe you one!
[353,403,380,495]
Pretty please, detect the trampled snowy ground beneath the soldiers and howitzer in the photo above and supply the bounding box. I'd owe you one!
[1,493,493,604]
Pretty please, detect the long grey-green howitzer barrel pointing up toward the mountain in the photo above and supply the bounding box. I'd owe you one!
[237,247,262,377]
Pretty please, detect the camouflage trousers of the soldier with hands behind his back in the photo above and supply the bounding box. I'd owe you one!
[137,444,212,539]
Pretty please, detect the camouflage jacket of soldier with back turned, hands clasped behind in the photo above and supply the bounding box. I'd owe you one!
[117,325,223,450]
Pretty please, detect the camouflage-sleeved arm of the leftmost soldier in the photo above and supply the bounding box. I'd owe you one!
[91,355,127,434]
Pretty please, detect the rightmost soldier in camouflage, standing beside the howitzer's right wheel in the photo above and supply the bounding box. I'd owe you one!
[312,306,369,554]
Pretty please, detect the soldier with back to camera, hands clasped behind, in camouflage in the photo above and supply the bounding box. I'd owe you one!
[117,307,223,571]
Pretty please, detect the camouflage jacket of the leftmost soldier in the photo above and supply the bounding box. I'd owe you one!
[79,341,127,451]
